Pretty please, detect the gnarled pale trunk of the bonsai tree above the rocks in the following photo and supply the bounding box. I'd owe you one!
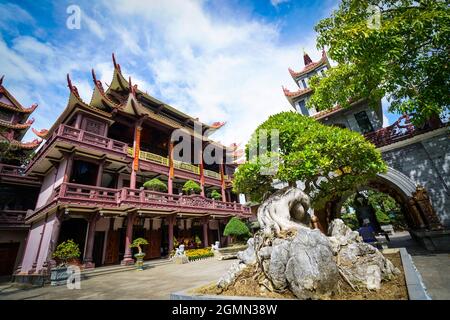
[257,187,311,235]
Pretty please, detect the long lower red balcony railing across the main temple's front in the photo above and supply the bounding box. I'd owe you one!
[30,183,251,219]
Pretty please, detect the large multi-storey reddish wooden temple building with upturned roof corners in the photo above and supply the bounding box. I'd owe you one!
[1,56,251,276]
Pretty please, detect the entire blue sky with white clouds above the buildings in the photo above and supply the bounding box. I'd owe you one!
[0,0,397,144]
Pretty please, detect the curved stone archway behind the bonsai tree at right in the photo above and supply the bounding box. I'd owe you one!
[314,167,442,232]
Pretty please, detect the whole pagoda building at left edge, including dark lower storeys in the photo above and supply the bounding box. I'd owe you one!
[0,76,42,276]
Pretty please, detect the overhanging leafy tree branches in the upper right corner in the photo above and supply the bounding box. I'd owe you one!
[308,0,450,124]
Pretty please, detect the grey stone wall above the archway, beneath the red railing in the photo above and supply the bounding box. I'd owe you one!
[381,128,450,227]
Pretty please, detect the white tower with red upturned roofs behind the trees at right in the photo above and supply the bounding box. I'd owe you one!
[283,50,383,134]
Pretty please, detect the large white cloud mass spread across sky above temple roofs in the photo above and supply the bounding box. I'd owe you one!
[0,0,326,148]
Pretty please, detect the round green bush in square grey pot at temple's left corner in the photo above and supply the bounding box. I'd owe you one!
[50,239,81,286]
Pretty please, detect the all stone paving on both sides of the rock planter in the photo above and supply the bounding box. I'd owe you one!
[0,232,450,300]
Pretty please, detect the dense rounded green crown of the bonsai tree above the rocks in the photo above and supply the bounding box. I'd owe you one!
[233,112,387,208]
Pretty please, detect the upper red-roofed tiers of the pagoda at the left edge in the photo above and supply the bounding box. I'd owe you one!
[0,76,42,165]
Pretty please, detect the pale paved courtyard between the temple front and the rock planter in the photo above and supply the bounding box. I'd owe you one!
[0,258,236,300]
